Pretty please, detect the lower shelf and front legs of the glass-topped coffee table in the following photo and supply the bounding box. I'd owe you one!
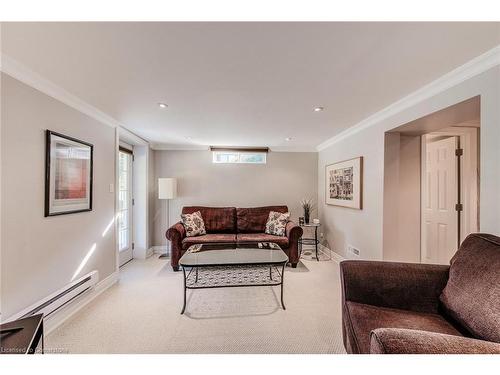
[181,262,286,314]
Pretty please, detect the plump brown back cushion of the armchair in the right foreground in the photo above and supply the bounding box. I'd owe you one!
[440,233,500,343]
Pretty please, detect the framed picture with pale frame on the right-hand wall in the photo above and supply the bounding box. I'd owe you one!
[325,156,363,210]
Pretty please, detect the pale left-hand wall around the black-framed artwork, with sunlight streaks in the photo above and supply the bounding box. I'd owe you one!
[1,74,116,318]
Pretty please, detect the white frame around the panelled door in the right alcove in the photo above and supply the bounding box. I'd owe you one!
[420,126,480,262]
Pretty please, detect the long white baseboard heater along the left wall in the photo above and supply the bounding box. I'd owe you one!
[4,271,99,321]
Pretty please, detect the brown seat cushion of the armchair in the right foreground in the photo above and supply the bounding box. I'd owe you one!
[345,301,462,354]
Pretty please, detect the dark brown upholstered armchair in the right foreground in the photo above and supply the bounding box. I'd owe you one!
[340,233,500,354]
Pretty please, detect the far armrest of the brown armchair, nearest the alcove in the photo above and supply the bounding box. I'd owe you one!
[340,260,449,313]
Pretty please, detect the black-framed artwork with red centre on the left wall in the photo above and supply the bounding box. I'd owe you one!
[45,130,94,217]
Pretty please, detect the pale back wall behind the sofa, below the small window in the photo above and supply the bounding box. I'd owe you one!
[154,151,318,246]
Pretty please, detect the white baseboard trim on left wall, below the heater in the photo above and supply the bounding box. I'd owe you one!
[43,271,119,335]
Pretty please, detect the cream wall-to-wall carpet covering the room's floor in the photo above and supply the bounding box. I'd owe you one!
[46,255,345,353]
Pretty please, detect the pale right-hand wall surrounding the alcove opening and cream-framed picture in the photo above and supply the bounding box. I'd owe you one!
[318,65,500,259]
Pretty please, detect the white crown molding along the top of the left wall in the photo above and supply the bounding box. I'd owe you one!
[0,53,122,128]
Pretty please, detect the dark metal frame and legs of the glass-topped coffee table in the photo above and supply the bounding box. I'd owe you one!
[179,244,288,315]
